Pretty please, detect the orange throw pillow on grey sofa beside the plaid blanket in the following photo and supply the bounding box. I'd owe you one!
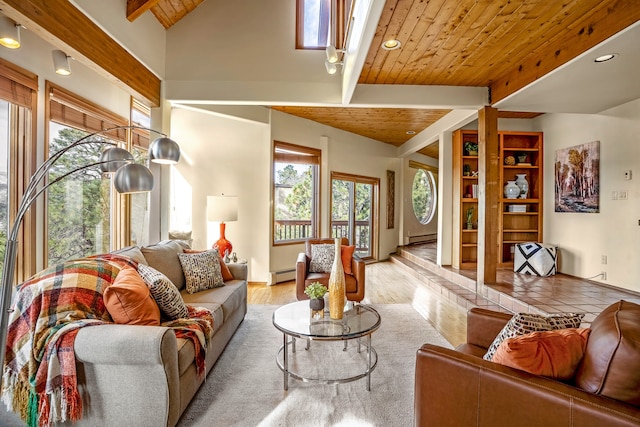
[103,267,160,326]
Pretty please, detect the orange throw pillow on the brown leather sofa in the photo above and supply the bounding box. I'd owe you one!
[491,328,591,380]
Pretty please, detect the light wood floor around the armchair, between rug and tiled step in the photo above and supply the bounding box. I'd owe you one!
[248,261,467,346]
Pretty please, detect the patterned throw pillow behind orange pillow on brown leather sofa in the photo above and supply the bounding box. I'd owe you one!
[482,313,584,361]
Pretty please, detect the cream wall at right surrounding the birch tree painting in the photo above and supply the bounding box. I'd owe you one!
[535,100,640,291]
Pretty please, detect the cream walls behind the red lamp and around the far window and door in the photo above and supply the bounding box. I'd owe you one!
[171,107,400,282]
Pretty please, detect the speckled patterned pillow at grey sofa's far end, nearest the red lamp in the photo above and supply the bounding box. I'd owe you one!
[178,250,224,294]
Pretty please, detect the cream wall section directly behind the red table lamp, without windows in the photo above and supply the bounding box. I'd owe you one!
[171,108,271,282]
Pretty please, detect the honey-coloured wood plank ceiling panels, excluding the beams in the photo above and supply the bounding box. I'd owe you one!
[127,0,640,157]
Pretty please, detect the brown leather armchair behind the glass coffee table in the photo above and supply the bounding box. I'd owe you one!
[296,237,365,302]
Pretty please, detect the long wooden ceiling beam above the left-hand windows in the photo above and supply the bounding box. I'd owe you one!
[0,0,160,107]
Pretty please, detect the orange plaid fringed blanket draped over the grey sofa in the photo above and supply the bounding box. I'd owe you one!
[2,255,213,427]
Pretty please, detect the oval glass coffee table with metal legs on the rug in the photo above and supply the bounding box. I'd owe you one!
[273,301,380,390]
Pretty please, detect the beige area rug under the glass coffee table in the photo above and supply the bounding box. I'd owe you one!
[178,304,451,427]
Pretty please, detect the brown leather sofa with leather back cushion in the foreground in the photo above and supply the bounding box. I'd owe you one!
[414,301,640,427]
